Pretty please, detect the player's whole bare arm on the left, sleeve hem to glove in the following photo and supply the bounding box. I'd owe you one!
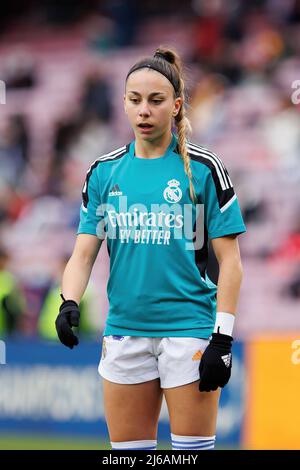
[62,233,102,304]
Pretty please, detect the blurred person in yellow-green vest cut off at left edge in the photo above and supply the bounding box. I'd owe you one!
[0,248,26,337]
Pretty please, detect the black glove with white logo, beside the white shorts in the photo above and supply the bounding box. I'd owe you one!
[199,333,233,392]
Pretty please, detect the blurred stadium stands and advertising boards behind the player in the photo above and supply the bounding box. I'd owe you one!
[0,0,300,449]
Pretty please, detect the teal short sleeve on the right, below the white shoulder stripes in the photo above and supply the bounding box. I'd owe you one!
[203,163,246,239]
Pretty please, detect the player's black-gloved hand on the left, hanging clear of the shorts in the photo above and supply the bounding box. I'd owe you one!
[55,300,80,349]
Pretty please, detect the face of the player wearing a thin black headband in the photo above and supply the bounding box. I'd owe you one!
[124,69,182,141]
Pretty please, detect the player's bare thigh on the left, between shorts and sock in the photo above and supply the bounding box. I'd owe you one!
[103,379,163,442]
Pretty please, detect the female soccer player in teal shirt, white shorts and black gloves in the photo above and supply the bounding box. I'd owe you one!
[56,48,245,450]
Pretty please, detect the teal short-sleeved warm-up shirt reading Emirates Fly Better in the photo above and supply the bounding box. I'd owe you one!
[78,135,246,338]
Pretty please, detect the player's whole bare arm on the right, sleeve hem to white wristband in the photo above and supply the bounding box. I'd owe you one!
[212,236,243,315]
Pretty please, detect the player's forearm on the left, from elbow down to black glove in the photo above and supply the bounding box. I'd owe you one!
[62,254,93,303]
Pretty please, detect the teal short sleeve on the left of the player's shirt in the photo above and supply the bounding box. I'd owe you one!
[77,168,105,239]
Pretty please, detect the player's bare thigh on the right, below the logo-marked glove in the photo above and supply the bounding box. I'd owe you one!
[164,380,220,436]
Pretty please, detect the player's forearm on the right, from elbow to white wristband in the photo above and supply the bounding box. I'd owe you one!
[217,258,243,315]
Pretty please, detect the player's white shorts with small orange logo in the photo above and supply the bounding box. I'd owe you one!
[98,335,208,388]
